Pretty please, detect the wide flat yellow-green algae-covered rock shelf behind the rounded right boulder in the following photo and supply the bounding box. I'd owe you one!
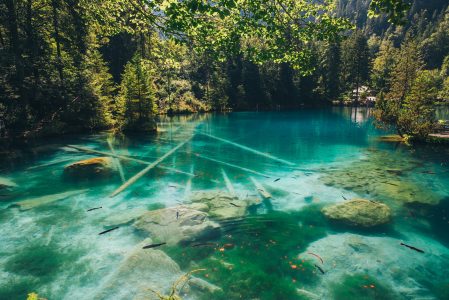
[320,151,442,205]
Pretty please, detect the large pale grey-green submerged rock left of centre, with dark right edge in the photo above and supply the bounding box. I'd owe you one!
[134,205,220,245]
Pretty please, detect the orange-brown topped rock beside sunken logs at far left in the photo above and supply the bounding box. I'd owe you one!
[64,157,115,179]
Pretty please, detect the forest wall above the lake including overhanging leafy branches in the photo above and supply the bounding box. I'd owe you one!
[0,0,449,136]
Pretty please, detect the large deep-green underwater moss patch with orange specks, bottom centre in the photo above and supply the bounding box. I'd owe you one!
[167,205,326,299]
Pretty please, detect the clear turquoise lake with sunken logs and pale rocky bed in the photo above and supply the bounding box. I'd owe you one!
[0,108,449,300]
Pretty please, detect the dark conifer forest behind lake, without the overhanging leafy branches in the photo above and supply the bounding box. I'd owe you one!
[0,0,449,135]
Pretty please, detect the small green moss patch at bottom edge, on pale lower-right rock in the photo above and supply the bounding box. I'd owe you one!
[333,274,394,300]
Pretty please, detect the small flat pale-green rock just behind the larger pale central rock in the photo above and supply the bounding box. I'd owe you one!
[190,191,260,219]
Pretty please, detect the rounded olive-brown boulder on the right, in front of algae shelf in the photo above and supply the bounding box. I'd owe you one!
[322,199,391,227]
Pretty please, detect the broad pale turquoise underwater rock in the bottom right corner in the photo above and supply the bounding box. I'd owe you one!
[298,233,449,300]
